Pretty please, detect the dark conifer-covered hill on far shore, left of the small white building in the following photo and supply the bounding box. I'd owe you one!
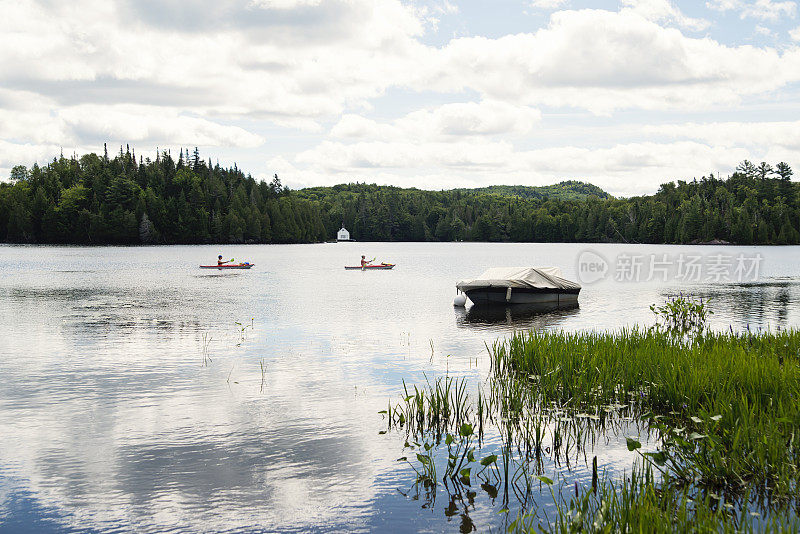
[0,148,326,244]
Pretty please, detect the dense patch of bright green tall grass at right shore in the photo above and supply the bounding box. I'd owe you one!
[492,328,800,497]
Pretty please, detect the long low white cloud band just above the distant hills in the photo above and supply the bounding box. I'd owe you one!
[286,141,753,195]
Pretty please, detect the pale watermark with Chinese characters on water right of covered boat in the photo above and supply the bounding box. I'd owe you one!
[577,250,763,284]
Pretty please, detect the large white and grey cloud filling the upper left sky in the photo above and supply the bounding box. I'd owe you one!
[0,0,432,119]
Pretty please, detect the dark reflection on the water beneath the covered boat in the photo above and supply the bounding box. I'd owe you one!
[456,303,580,330]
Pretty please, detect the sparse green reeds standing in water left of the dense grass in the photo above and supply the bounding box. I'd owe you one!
[380,376,640,520]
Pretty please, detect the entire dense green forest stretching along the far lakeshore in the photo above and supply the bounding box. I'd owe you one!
[0,148,800,244]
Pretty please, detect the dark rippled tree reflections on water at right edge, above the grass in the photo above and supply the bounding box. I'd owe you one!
[662,280,800,329]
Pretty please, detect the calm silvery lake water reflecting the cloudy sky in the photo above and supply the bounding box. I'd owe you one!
[0,243,800,532]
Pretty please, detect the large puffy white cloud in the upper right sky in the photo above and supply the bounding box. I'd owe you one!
[423,10,800,114]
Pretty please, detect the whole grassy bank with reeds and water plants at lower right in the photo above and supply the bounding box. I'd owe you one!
[386,301,800,532]
